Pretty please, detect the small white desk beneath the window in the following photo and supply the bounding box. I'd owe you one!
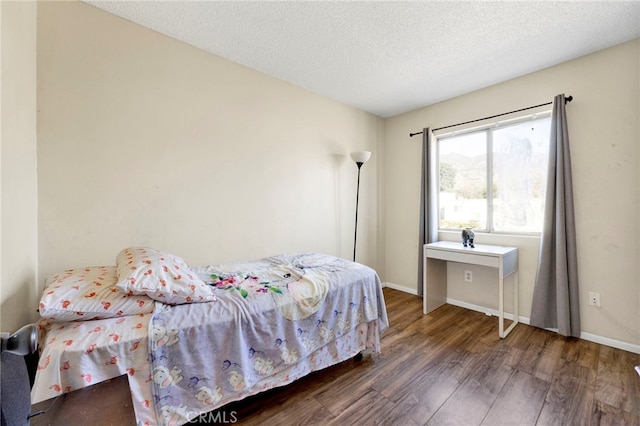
[422,241,518,338]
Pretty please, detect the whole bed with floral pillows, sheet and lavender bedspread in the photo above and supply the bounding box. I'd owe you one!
[31,247,388,425]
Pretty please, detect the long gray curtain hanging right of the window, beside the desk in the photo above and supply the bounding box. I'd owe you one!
[531,95,580,337]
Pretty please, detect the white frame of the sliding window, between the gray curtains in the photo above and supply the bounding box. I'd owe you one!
[431,109,552,236]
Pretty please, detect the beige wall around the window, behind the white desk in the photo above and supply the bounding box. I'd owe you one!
[381,40,640,345]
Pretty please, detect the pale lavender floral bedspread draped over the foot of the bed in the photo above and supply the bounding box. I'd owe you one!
[149,253,388,425]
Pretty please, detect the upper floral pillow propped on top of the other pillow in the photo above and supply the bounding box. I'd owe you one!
[116,247,216,305]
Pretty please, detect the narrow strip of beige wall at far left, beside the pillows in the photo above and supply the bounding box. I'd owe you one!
[0,1,38,332]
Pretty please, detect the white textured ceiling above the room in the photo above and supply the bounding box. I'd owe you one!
[86,0,640,117]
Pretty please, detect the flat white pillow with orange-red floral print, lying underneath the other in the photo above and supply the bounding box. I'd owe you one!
[39,266,153,321]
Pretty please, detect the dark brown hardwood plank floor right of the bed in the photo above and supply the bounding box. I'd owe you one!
[206,288,640,426]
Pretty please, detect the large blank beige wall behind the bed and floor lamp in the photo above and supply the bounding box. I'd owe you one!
[38,2,382,286]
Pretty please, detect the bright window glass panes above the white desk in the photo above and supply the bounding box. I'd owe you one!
[437,114,551,233]
